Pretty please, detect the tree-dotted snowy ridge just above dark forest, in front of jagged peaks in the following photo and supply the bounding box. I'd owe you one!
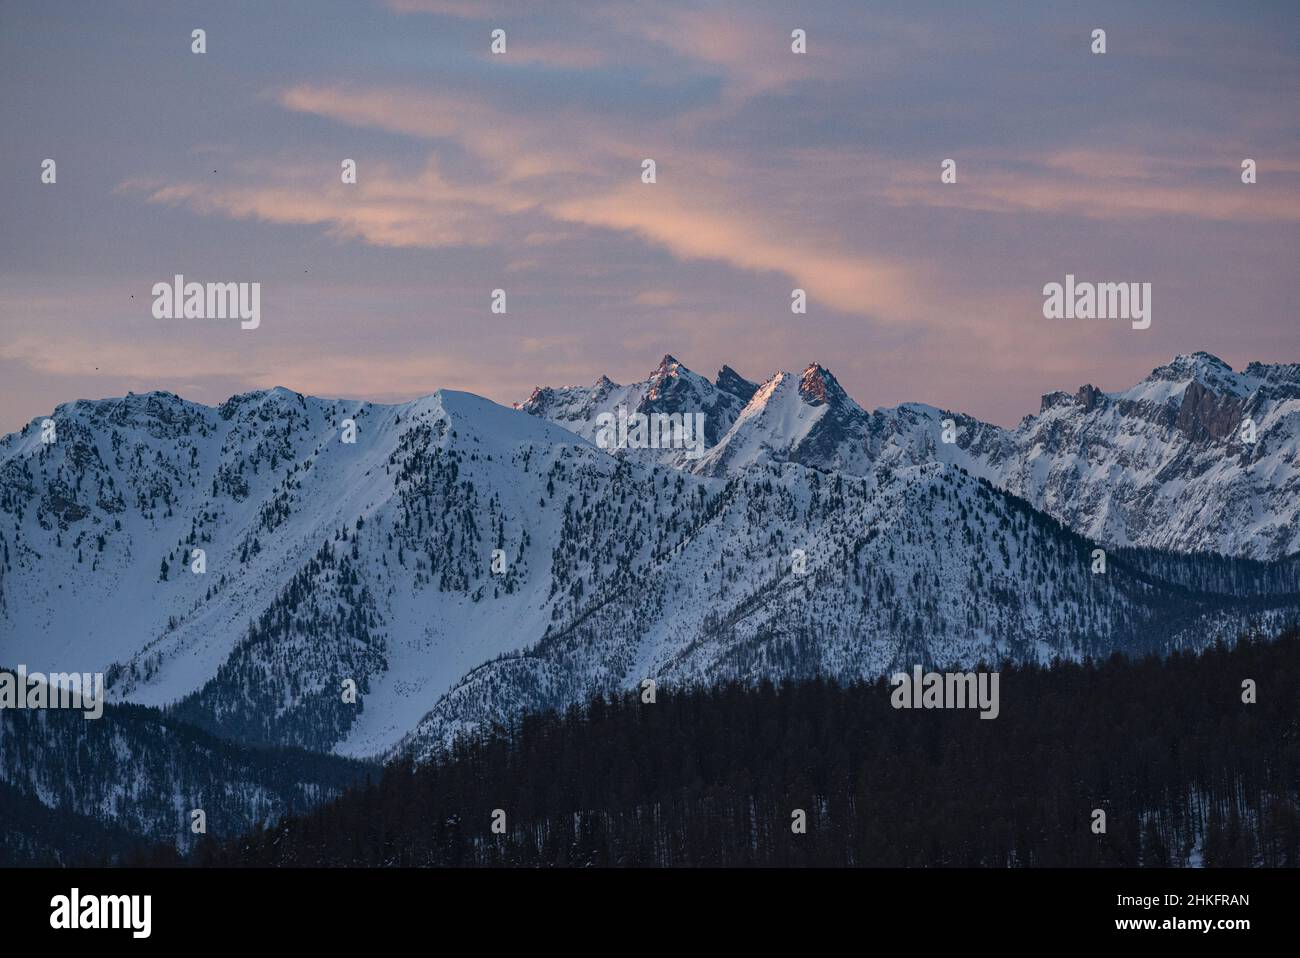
[403,463,1300,758]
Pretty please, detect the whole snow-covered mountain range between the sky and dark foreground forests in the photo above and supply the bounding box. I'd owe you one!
[0,354,1300,779]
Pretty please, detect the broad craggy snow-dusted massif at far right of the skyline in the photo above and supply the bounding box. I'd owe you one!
[956,352,1300,558]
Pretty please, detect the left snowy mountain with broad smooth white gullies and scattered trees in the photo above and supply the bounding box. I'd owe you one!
[0,390,603,754]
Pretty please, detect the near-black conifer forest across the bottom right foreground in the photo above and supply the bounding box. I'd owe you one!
[175,632,1300,867]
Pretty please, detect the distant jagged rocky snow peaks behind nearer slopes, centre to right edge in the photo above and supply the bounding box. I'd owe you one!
[519,352,1300,559]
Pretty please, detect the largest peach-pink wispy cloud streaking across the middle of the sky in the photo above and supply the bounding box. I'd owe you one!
[127,84,923,320]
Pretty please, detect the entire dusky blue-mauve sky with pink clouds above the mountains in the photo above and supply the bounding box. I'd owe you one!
[0,0,1300,432]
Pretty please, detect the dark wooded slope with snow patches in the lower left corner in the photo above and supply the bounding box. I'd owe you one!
[0,669,372,867]
